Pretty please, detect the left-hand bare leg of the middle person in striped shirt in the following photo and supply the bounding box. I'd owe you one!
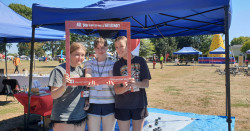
[88,115,101,131]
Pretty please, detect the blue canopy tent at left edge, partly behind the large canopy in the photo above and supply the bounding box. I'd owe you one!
[0,2,65,75]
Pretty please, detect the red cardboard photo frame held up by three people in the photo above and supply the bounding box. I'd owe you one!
[65,21,131,86]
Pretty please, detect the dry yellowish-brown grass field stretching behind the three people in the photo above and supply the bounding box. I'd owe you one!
[0,61,250,131]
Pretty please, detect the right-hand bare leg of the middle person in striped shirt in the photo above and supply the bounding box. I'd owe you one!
[102,114,116,131]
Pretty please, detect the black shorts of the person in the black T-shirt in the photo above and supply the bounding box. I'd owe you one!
[115,108,148,121]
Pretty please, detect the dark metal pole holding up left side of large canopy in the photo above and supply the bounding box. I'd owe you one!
[25,26,36,128]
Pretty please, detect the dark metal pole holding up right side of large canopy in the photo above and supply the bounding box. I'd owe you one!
[224,6,232,131]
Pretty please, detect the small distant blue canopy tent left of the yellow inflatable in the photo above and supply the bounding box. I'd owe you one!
[173,47,202,55]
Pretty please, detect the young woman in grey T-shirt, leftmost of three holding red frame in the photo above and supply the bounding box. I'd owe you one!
[49,43,87,131]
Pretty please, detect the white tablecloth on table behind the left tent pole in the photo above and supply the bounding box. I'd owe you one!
[8,74,49,88]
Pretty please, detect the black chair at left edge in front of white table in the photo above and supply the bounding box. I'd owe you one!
[2,79,20,101]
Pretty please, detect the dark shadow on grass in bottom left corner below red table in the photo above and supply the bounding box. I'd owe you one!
[0,114,43,131]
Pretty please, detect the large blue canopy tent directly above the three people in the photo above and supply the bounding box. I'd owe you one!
[30,0,232,130]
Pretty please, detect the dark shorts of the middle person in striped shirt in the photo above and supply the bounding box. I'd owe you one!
[88,103,115,116]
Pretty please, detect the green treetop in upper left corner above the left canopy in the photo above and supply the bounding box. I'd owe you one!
[9,3,32,20]
